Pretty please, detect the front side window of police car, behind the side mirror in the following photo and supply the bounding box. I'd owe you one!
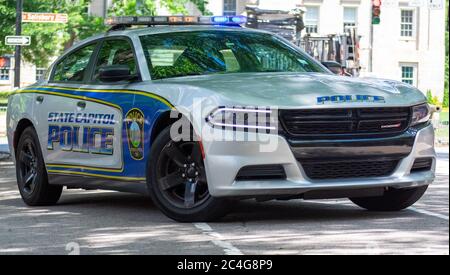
[94,39,137,82]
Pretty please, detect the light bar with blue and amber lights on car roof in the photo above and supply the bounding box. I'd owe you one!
[105,16,247,26]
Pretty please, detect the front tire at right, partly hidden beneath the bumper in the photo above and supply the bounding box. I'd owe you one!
[350,185,428,211]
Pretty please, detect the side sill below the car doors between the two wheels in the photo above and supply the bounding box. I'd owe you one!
[48,173,148,195]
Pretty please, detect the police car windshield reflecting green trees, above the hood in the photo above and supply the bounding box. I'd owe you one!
[141,31,325,79]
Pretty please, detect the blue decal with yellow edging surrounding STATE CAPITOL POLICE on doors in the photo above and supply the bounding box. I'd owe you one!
[19,87,173,181]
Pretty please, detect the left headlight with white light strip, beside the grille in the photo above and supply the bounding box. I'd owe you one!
[206,107,278,131]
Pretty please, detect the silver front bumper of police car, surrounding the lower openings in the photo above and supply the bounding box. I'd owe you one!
[203,125,436,197]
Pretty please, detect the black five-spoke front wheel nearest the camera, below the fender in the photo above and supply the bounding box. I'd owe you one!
[147,127,229,222]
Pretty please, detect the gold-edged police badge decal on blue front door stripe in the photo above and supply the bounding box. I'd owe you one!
[125,109,145,160]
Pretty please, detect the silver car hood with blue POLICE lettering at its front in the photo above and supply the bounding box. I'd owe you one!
[150,73,426,108]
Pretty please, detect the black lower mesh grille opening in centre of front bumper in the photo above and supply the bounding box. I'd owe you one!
[300,160,399,180]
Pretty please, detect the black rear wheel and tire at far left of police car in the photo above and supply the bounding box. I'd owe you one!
[16,126,63,206]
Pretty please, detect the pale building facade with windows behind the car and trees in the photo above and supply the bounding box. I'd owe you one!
[0,0,446,99]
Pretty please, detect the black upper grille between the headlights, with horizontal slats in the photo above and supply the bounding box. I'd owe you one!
[279,107,411,138]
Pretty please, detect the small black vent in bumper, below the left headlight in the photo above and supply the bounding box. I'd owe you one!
[236,165,286,180]
